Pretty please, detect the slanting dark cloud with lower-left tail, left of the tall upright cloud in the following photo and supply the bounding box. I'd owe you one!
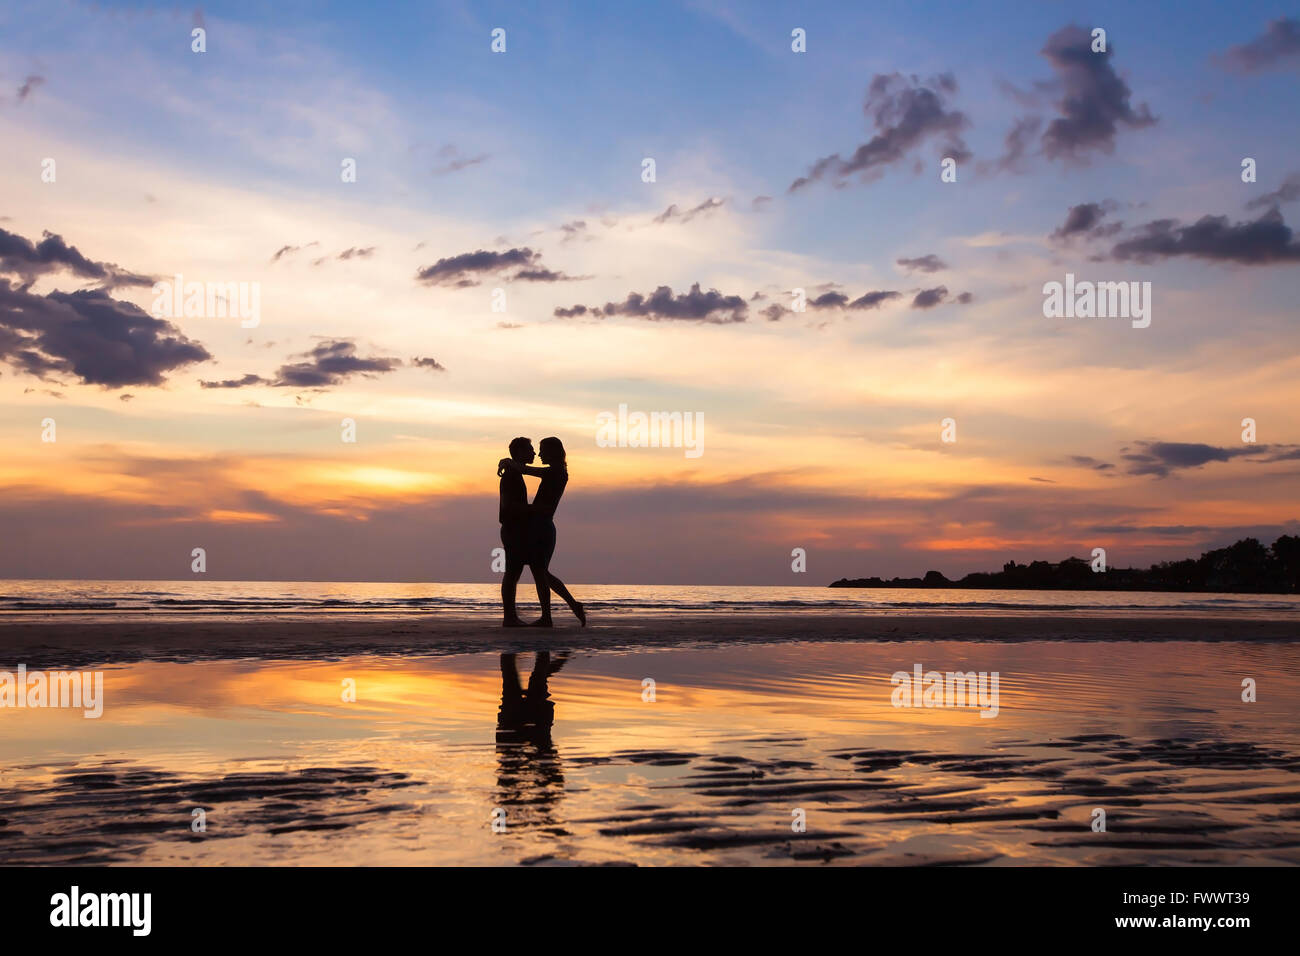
[789,73,970,193]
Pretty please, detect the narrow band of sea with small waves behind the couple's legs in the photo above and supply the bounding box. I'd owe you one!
[0,580,1300,618]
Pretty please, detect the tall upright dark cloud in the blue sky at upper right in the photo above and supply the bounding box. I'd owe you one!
[1024,25,1156,168]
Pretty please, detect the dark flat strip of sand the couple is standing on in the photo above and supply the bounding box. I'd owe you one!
[0,613,1300,669]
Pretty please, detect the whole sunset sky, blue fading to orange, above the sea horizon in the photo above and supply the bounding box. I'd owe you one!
[0,0,1300,584]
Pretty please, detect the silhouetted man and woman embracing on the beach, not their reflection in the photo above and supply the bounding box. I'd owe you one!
[497,438,586,627]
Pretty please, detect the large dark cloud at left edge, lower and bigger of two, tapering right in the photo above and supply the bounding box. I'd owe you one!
[0,278,212,389]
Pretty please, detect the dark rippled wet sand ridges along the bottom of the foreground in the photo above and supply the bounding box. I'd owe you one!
[10,734,1300,866]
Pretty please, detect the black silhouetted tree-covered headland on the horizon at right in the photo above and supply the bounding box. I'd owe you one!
[831,535,1300,594]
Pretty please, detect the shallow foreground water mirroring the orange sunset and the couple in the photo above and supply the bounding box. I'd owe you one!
[0,642,1300,865]
